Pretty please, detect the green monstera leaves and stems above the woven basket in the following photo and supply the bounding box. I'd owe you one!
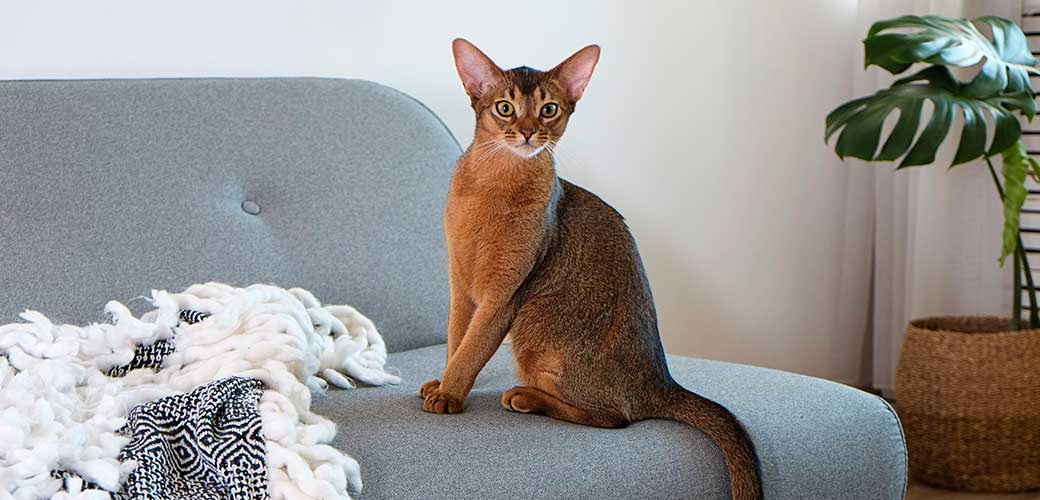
[825,16,1040,330]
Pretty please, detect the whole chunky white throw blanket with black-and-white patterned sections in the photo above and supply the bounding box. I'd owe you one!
[0,283,400,500]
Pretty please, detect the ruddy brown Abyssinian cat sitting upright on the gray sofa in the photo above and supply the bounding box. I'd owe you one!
[420,38,761,500]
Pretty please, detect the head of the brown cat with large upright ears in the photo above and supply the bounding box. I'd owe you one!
[451,38,599,158]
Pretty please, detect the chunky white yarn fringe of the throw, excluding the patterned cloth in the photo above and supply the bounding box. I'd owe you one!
[0,283,400,500]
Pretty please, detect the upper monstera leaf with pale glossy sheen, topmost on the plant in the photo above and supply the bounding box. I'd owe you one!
[863,16,1040,97]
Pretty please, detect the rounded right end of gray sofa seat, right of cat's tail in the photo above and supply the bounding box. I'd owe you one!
[669,357,907,500]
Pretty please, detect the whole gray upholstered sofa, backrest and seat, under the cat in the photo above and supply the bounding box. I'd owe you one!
[0,78,906,500]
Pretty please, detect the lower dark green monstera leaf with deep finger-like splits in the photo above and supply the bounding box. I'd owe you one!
[824,65,1036,168]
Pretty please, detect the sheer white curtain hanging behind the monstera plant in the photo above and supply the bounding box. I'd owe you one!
[846,0,1022,394]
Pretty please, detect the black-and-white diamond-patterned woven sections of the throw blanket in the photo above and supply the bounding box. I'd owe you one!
[59,310,268,500]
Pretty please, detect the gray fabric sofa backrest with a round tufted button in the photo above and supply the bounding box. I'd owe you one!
[0,78,460,350]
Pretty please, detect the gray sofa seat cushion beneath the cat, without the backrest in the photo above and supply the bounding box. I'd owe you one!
[314,345,906,500]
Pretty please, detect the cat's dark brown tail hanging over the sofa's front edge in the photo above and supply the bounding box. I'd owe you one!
[662,387,762,500]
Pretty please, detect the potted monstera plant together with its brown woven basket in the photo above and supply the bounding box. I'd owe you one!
[825,16,1040,492]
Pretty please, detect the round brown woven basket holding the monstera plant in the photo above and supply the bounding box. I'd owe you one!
[895,317,1040,493]
